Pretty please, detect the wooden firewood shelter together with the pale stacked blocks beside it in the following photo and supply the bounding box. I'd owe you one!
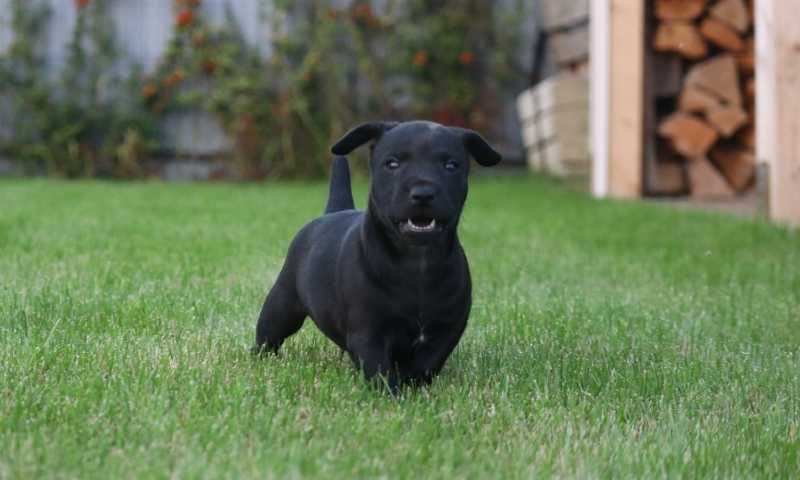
[518,0,800,225]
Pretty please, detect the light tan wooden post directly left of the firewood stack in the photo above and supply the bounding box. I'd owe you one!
[608,0,645,198]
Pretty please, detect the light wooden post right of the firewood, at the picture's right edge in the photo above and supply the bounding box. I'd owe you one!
[759,0,800,226]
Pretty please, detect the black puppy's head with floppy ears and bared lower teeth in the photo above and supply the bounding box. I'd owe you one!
[331,121,502,245]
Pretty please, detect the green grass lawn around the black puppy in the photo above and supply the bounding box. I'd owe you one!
[0,178,800,479]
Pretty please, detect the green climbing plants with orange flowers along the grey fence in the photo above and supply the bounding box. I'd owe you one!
[0,0,522,179]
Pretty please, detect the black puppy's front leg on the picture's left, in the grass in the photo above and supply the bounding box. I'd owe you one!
[347,332,400,393]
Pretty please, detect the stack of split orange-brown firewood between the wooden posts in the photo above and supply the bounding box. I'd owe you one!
[650,0,755,198]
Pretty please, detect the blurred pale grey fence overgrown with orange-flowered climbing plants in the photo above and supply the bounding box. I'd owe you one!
[0,0,556,180]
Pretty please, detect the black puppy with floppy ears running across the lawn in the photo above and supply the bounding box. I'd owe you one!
[256,121,501,389]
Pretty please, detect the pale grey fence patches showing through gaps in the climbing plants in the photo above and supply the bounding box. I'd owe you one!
[0,0,538,158]
